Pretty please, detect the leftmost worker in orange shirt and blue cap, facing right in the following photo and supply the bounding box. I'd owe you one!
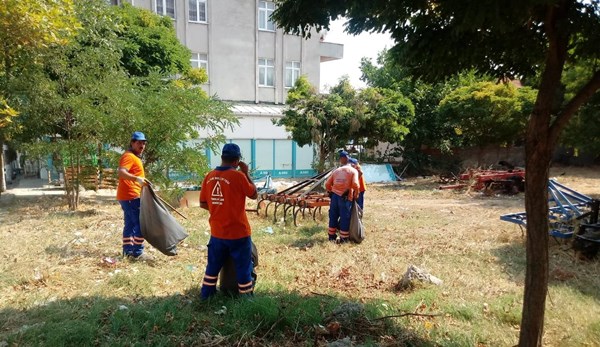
[117,131,149,260]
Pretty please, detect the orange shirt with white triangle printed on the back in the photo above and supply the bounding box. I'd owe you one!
[200,166,256,240]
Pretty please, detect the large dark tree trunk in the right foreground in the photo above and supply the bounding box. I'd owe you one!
[519,0,572,347]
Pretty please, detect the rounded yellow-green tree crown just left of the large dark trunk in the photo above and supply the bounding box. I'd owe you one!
[438,82,536,147]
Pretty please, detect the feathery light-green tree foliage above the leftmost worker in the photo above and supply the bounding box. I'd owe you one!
[15,0,237,208]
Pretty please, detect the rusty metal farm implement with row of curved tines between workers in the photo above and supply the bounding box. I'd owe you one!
[256,170,332,226]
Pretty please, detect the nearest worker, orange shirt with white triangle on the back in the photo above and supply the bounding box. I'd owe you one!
[200,143,258,300]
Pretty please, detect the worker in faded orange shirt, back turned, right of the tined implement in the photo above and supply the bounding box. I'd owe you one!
[325,151,359,243]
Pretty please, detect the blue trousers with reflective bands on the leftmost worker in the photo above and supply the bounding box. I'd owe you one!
[119,198,144,257]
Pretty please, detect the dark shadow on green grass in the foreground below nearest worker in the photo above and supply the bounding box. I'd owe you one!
[0,289,434,346]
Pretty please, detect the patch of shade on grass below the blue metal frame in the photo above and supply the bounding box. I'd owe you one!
[492,242,600,300]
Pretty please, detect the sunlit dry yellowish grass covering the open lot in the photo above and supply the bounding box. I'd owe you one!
[0,167,600,346]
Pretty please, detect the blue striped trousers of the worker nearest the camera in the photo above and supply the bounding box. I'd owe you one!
[200,236,254,299]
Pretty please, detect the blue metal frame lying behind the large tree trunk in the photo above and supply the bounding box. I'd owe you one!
[500,179,592,239]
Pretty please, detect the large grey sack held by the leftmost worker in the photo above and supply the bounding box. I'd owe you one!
[140,185,188,256]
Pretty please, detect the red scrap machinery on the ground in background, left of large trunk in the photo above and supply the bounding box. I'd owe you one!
[440,169,525,194]
